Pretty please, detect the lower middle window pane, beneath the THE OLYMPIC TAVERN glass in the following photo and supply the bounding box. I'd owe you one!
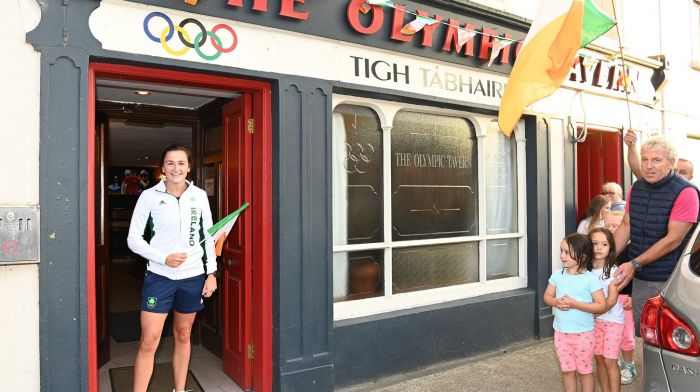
[392,242,479,293]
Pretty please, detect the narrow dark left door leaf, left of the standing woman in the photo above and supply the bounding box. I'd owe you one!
[94,120,109,367]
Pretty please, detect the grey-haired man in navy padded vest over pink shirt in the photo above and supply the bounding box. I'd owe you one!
[614,137,700,334]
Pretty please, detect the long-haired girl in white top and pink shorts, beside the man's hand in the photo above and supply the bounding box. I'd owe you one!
[589,227,625,392]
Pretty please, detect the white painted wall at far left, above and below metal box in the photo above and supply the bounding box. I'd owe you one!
[0,0,41,391]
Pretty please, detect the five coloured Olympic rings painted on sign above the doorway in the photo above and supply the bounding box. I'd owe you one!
[143,12,238,61]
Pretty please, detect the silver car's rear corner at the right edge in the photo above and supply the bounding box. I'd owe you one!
[640,225,700,392]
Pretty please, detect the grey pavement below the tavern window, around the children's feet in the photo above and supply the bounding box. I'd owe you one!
[339,339,644,392]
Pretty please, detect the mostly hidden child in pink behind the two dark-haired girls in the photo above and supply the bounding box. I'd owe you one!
[605,211,637,385]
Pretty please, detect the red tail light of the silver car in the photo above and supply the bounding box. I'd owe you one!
[640,295,700,357]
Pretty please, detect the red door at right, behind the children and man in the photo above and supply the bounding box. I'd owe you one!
[576,128,622,222]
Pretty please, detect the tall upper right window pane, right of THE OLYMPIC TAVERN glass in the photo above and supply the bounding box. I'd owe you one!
[484,121,518,234]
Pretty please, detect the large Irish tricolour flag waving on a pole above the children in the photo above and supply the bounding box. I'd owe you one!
[498,0,615,136]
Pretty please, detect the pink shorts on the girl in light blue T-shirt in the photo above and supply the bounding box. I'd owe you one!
[554,331,595,374]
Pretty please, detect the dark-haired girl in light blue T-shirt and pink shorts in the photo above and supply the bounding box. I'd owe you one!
[544,233,606,392]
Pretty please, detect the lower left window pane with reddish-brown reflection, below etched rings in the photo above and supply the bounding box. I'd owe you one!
[333,250,384,302]
